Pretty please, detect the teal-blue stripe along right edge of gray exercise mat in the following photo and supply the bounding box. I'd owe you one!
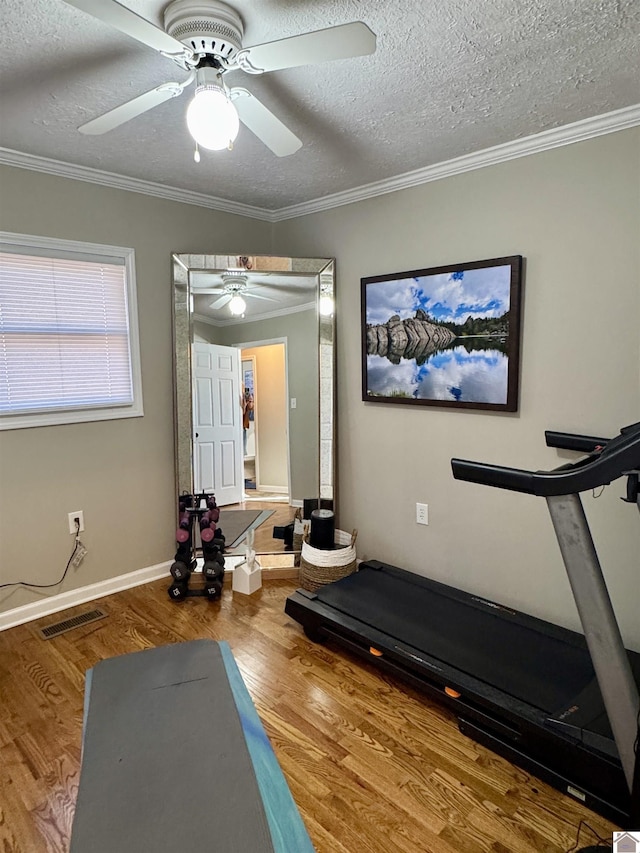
[219,641,315,853]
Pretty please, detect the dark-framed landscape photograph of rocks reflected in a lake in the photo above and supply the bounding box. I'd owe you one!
[361,255,522,412]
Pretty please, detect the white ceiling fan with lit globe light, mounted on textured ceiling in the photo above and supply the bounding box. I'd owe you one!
[64,0,376,156]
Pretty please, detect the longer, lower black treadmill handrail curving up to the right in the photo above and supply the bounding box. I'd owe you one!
[451,423,640,497]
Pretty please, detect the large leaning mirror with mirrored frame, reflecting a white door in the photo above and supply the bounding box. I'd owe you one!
[172,254,335,553]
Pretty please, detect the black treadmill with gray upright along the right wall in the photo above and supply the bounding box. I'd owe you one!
[285,423,640,828]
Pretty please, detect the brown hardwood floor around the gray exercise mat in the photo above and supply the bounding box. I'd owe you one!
[0,580,614,853]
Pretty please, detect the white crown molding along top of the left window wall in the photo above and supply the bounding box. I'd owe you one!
[0,148,272,222]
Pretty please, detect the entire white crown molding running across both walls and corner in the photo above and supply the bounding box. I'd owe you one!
[0,104,640,222]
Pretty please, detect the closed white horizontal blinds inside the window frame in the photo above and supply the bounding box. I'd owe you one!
[0,251,134,415]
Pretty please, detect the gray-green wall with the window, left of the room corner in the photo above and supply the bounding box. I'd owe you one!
[0,167,272,611]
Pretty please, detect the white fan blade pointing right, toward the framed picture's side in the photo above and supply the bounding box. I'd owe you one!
[234,21,376,74]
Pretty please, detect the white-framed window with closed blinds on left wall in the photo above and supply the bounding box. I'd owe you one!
[0,232,142,429]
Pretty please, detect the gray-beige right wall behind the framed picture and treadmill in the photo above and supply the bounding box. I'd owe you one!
[274,128,640,649]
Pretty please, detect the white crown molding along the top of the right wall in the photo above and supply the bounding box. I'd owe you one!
[272,104,640,222]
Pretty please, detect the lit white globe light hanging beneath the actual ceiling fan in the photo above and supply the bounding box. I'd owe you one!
[187,68,240,151]
